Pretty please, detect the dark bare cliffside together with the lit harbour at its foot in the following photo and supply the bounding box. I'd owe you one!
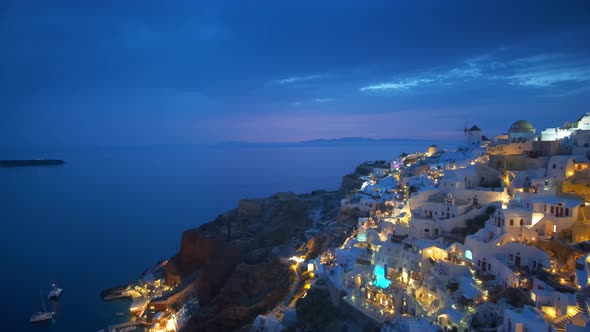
[101,163,370,331]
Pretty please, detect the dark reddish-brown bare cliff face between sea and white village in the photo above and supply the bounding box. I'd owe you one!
[167,171,362,331]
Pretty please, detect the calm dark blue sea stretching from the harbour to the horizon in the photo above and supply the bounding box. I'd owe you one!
[0,141,456,331]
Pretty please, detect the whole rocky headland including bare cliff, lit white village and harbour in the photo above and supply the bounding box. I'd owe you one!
[97,115,590,331]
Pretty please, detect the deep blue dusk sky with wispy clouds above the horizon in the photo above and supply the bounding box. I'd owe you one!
[0,0,590,148]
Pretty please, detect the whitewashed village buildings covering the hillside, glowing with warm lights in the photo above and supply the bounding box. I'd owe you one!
[320,114,590,331]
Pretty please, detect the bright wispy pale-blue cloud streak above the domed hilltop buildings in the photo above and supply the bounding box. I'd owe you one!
[359,54,590,92]
